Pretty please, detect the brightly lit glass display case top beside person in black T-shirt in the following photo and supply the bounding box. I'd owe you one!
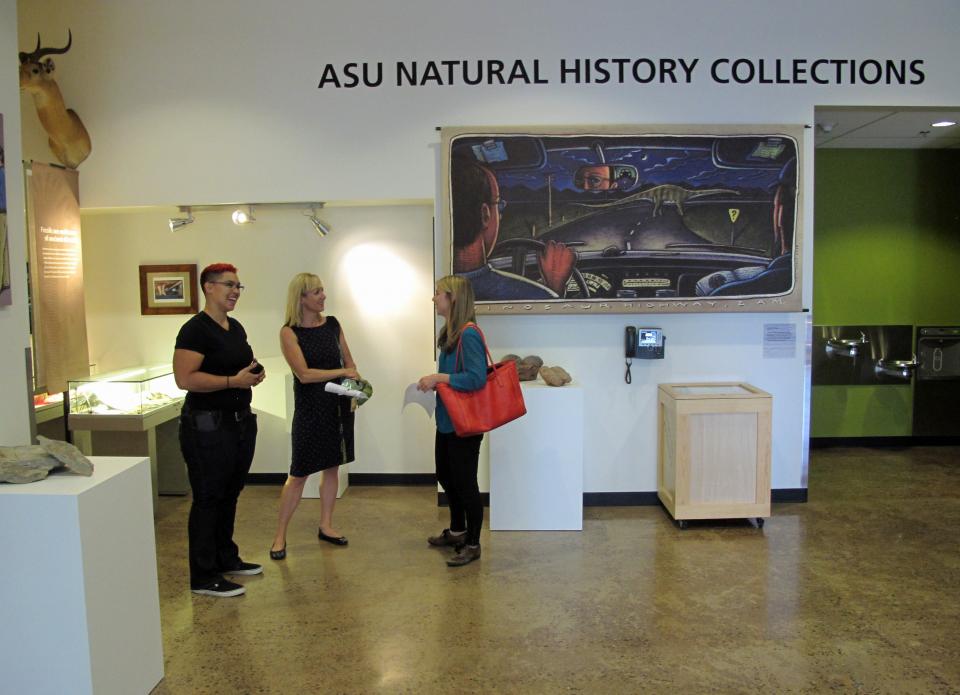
[67,364,185,415]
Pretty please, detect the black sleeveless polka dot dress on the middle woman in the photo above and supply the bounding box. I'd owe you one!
[290,316,354,477]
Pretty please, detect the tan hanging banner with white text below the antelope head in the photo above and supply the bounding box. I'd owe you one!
[27,163,90,393]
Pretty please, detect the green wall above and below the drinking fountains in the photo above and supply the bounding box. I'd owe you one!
[811,149,960,437]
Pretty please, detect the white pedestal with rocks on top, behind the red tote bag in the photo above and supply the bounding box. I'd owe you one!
[489,381,583,531]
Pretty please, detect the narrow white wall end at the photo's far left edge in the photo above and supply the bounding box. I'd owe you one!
[0,0,30,446]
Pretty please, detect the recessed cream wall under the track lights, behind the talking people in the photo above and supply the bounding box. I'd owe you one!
[82,205,435,473]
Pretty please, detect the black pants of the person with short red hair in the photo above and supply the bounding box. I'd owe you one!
[180,411,257,588]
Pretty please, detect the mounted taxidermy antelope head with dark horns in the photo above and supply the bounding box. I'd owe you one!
[20,30,90,169]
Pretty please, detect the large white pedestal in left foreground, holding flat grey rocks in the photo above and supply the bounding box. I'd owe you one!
[0,457,163,695]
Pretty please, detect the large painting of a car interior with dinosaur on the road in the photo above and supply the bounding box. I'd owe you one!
[441,125,803,314]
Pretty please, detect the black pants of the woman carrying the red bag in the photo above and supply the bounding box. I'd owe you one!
[434,432,483,545]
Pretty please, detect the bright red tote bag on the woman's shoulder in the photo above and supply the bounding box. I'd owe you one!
[437,323,527,437]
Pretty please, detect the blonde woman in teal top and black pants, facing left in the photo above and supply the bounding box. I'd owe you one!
[417,275,487,567]
